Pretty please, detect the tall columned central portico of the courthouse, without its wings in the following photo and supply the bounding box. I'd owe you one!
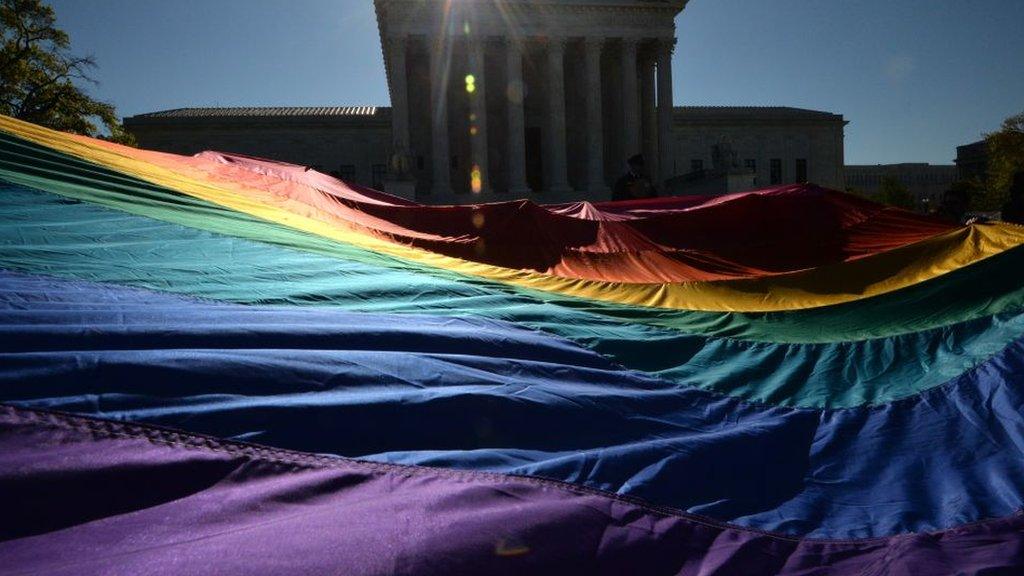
[375,0,686,201]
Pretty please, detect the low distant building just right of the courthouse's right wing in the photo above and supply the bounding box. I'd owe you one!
[846,163,959,210]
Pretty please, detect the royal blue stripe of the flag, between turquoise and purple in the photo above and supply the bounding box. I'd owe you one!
[0,273,1024,538]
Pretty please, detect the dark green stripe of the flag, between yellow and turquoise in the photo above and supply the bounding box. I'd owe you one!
[0,130,1024,343]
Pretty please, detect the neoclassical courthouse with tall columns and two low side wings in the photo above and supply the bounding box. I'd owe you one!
[125,0,846,203]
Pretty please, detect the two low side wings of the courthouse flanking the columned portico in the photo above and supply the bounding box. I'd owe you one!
[125,107,846,202]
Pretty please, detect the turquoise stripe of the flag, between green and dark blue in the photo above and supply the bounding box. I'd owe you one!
[0,181,1024,408]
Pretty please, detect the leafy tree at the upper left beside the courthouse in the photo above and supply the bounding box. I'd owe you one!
[0,0,133,143]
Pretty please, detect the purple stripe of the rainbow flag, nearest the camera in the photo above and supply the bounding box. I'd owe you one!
[0,406,1024,576]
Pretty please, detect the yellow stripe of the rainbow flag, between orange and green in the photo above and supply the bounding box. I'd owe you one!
[0,114,1024,312]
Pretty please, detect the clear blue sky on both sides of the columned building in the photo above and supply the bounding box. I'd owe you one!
[51,0,1024,164]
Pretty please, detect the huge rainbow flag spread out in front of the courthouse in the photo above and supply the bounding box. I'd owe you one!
[0,117,1024,575]
